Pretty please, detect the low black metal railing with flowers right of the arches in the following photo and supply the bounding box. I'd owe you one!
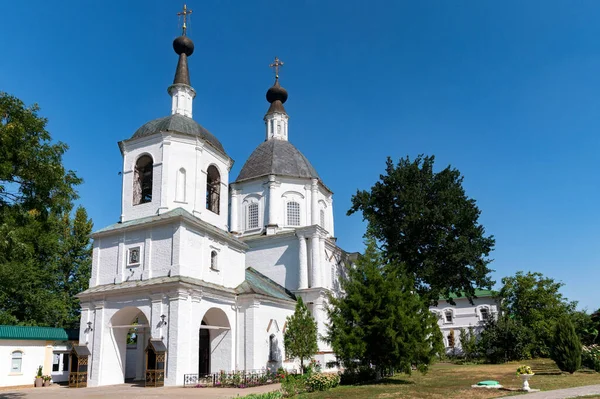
[183,370,280,388]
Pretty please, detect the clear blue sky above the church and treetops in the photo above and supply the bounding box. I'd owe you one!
[0,0,600,310]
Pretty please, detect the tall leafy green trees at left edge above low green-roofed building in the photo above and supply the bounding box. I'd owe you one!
[0,92,91,327]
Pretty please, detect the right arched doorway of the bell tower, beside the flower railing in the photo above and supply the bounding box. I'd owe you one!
[198,308,233,376]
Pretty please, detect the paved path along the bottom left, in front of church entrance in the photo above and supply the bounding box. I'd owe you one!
[0,384,281,399]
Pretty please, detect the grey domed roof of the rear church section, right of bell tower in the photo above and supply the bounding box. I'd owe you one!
[236,139,319,181]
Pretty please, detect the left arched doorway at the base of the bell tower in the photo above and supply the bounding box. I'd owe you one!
[102,307,149,385]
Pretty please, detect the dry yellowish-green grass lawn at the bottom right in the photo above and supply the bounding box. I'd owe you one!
[299,359,600,399]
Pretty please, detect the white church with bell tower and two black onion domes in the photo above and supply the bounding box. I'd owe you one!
[78,25,349,386]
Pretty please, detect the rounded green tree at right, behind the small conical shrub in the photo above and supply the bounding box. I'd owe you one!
[500,272,577,357]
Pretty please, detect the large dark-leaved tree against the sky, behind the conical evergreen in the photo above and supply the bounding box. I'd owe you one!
[348,156,495,303]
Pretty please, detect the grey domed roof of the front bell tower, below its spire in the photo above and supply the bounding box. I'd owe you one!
[131,114,227,155]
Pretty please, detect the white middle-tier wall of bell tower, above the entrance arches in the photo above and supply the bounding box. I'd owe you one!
[90,220,245,288]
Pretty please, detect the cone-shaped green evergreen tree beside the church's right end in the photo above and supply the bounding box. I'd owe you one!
[327,238,441,374]
